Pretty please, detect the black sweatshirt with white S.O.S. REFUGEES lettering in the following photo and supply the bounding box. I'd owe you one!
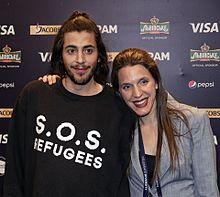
[3,81,134,197]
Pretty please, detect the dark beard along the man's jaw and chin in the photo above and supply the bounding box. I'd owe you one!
[65,66,97,85]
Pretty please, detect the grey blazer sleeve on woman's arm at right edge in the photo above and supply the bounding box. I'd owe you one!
[192,110,219,197]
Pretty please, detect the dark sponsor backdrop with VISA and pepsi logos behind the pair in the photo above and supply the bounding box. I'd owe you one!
[0,0,220,194]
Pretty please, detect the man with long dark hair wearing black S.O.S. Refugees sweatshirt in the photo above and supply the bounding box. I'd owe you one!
[3,11,133,197]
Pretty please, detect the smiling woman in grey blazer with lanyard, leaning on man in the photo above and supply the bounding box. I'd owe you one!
[112,48,219,197]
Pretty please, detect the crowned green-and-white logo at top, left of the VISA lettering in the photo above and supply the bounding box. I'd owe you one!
[140,16,170,35]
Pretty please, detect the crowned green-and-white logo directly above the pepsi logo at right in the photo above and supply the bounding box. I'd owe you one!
[190,43,220,62]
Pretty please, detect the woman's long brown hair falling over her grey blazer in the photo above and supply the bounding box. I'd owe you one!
[111,48,188,180]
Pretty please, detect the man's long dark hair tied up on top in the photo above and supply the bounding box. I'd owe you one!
[51,11,109,84]
